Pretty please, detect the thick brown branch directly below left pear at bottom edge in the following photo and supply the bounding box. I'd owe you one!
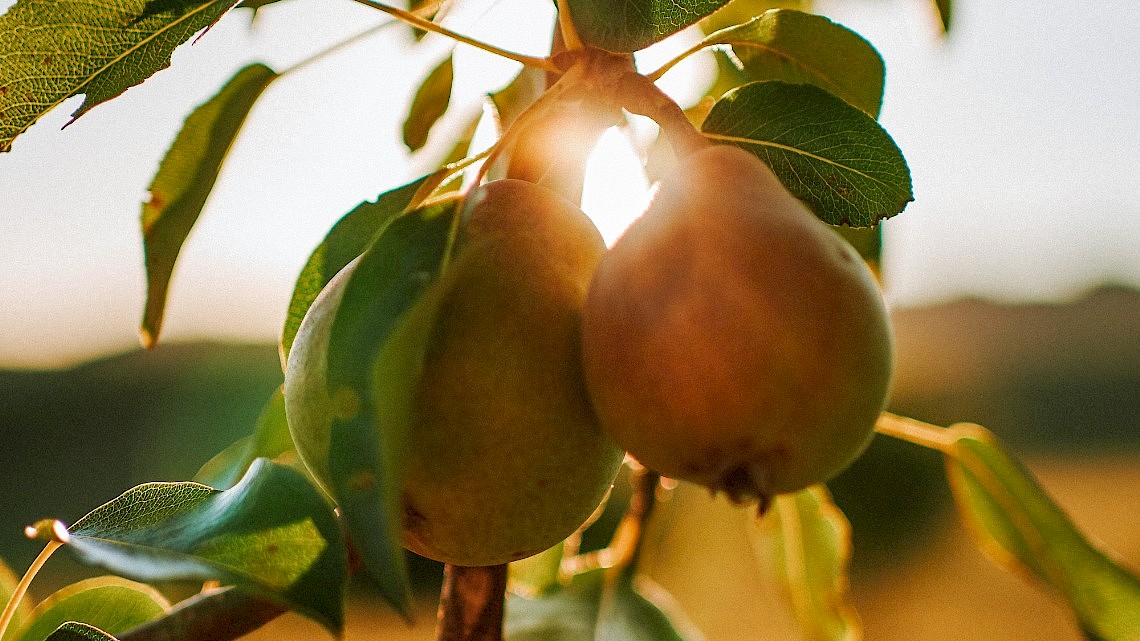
[435,563,507,641]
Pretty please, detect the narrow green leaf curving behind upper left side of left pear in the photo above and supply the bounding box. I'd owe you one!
[282,177,428,364]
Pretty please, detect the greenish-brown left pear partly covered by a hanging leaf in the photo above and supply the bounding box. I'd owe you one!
[285,180,624,566]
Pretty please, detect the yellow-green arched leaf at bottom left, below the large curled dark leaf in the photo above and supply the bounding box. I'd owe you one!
[6,576,170,641]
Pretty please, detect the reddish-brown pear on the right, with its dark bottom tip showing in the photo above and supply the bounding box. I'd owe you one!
[583,146,894,508]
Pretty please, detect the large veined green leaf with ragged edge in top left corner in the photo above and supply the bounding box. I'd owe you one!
[0,0,234,152]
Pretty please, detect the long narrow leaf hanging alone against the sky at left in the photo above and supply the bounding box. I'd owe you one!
[141,64,277,348]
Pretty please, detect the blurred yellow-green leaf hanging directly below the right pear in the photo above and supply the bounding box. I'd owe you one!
[752,485,862,641]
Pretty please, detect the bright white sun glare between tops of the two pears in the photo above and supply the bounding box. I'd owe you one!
[581,127,651,245]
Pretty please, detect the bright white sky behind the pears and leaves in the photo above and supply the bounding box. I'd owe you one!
[0,0,1140,367]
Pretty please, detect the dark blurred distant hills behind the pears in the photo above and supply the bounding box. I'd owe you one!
[0,281,1140,566]
